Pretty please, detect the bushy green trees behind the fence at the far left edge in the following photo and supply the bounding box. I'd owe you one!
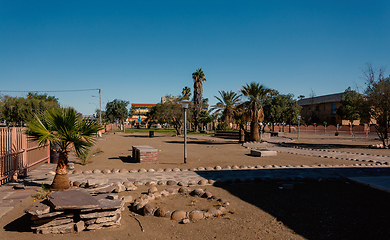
[0,93,60,126]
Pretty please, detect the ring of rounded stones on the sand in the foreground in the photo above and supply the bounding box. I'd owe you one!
[130,186,233,224]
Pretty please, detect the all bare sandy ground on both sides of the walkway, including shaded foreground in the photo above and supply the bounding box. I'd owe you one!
[0,134,390,240]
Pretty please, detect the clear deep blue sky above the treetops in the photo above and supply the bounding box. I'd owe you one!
[0,0,390,114]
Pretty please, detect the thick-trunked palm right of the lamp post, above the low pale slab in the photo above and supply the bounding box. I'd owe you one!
[240,82,271,141]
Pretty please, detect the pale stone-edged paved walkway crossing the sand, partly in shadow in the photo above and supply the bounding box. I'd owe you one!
[0,139,390,218]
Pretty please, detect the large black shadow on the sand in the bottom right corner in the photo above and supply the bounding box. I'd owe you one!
[197,170,390,239]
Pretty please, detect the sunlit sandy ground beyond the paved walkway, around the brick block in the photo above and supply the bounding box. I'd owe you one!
[71,133,378,170]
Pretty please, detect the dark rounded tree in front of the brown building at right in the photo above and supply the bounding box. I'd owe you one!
[336,87,364,127]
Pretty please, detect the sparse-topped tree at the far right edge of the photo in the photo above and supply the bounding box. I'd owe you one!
[364,64,390,148]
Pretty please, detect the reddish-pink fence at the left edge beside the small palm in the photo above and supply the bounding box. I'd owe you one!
[0,127,50,184]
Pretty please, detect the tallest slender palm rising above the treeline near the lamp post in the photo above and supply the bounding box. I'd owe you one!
[192,68,206,132]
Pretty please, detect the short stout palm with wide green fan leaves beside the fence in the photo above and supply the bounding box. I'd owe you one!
[27,107,102,190]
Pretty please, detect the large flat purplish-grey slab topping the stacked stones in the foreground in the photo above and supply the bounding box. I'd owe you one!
[47,189,99,210]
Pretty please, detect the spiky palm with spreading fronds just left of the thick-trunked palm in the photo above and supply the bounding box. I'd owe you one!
[210,91,241,125]
